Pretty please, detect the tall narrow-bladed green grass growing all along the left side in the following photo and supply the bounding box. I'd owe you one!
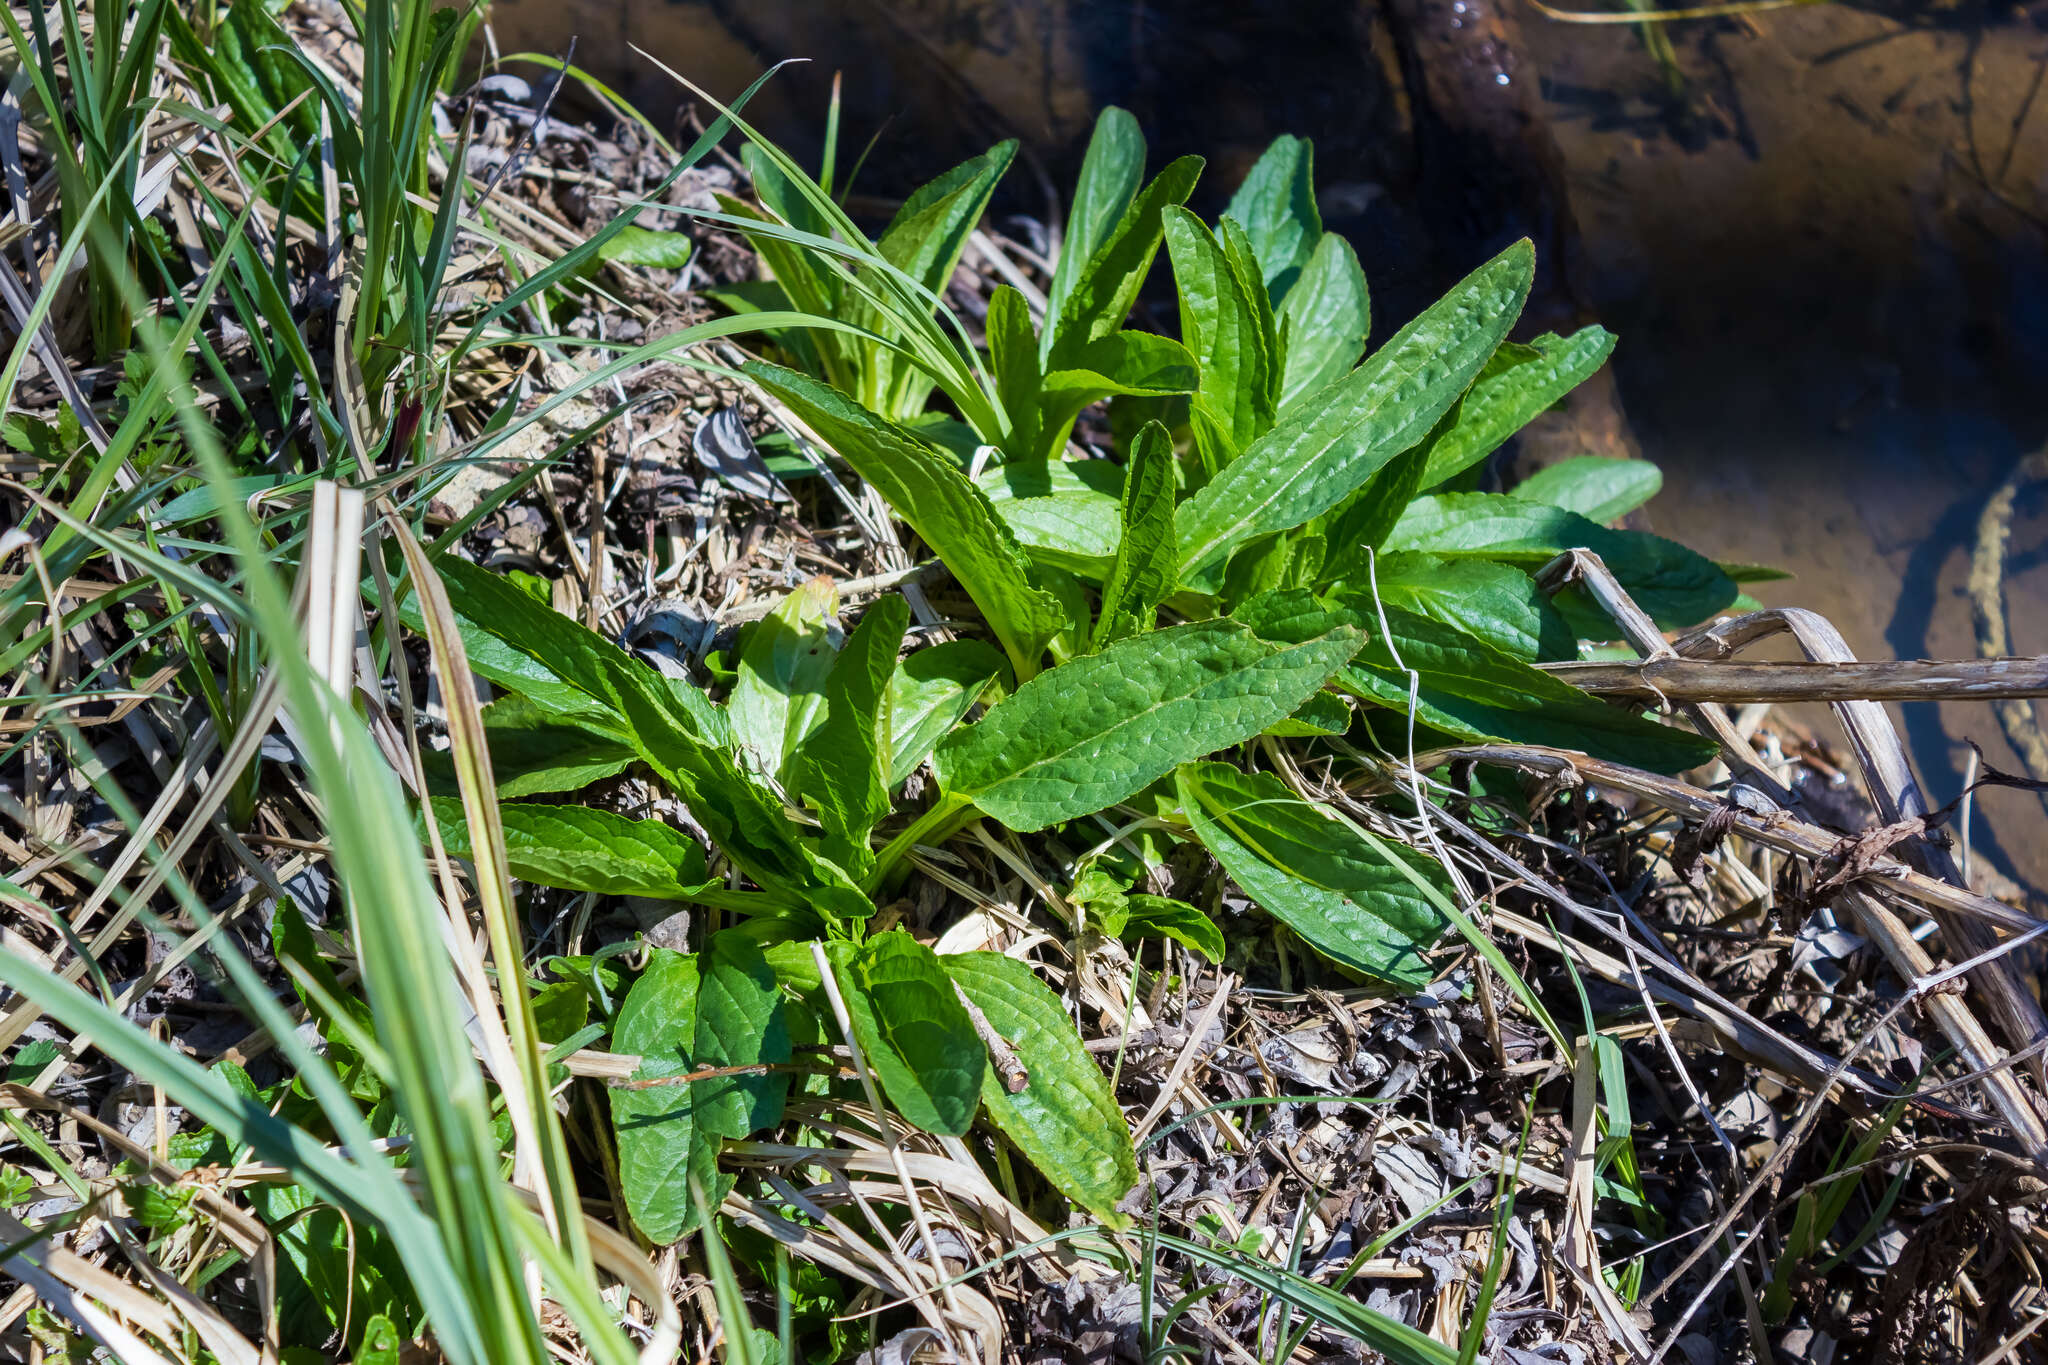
[0,0,790,1361]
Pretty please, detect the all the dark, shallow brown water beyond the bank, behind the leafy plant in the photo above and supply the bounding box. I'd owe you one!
[496,0,2048,888]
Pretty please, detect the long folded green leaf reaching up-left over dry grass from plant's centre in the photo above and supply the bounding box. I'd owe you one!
[745,360,1067,677]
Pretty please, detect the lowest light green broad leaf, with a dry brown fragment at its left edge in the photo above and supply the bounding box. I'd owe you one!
[942,952,1139,1228]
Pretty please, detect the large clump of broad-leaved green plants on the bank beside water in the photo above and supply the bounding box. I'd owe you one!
[399,101,1735,1309]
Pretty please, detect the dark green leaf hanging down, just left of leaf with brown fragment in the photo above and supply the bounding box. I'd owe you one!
[831,931,987,1136]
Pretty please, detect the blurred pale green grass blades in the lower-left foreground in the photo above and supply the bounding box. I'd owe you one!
[0,360,629,1361]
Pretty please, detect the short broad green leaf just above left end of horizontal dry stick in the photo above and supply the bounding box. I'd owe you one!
[1333,555,1579,663]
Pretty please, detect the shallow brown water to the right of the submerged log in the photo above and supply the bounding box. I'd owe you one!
[1526,6,2048,888]
